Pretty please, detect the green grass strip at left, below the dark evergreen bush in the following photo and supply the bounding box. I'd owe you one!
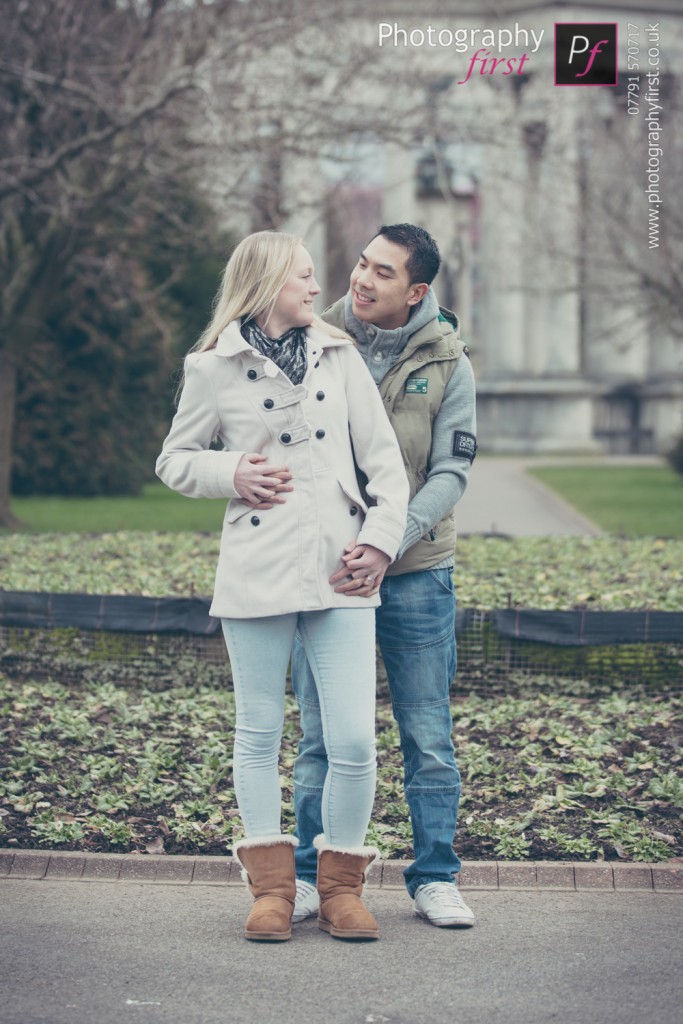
[12,483,225,534]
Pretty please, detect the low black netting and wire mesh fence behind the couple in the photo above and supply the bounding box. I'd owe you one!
[0,591,683,694]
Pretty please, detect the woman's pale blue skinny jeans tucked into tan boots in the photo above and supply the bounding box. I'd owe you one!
[221,608,377,847]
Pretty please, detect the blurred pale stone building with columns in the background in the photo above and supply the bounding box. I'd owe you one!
[264,0,683,454]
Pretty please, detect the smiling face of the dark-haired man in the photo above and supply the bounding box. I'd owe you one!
[350,234,429,331]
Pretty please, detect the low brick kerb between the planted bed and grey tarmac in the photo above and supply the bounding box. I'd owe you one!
[0,848,683,894]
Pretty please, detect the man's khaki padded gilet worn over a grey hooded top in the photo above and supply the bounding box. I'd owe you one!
[323,299,464,575]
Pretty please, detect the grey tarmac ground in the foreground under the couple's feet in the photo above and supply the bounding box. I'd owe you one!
[0,879,683,1024]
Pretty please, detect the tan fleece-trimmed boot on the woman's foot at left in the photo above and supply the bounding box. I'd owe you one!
[233,836,299,942]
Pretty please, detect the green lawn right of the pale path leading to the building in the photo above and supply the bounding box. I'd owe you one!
[527,466,683,538]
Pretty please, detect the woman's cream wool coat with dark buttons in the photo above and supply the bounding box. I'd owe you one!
[157,321,409,618]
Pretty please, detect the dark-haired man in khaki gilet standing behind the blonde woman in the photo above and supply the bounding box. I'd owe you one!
[292,224,476,928]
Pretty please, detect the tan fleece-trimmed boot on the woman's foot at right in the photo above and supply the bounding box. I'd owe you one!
[314,836,380,939]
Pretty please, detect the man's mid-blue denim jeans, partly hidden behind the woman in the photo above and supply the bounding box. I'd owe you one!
[292,569,460,896]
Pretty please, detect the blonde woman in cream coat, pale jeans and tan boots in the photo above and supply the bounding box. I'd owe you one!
[157,231,408,941]
